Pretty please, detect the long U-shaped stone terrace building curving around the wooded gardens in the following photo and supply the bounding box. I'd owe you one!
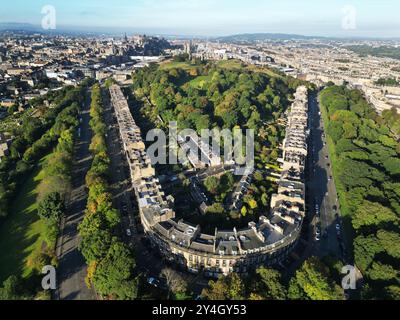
[110,85,308,277]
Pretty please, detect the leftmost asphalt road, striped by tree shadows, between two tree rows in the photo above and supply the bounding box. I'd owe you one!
[55,93,96,300]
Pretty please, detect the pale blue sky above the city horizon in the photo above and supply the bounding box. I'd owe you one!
[0,0,400,37]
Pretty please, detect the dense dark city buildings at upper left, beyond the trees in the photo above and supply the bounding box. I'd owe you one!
[0,33,170,106]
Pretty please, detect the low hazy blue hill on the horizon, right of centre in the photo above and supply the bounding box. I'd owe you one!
[216,33,324,42]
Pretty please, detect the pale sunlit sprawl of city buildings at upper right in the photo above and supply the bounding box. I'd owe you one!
[189,39,400,112]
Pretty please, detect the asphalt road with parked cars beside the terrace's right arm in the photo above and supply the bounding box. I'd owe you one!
[307,95,346,260]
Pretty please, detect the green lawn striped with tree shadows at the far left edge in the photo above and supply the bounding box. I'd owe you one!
[0,159,45,282]
